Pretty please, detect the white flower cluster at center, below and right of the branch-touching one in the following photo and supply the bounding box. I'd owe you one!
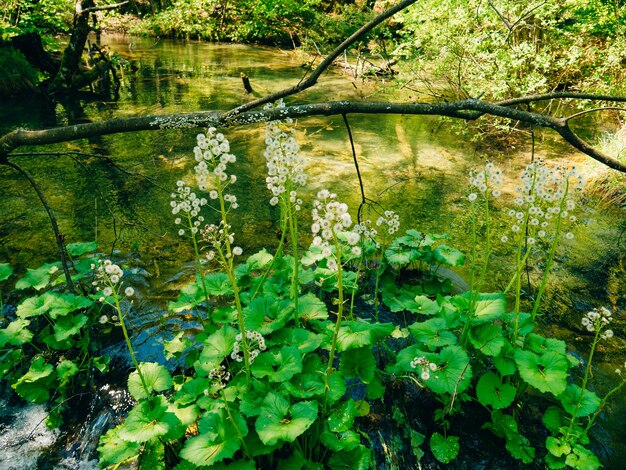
[311,189,361,271]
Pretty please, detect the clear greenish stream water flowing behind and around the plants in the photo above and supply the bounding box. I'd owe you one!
[0,36,626,470]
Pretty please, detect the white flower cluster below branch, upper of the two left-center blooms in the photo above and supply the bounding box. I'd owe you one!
[193,127,237,192]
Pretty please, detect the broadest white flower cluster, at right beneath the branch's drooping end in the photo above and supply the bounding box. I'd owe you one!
[501,161,584,245]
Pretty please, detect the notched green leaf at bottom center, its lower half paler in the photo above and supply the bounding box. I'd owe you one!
[255,392,317,445]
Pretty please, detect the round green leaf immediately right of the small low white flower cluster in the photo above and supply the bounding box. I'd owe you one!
[425,345,472,394]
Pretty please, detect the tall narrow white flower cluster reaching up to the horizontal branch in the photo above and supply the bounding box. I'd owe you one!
[263,100,307,210]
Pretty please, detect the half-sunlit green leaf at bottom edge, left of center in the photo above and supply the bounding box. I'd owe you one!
[180,410,248,467]
